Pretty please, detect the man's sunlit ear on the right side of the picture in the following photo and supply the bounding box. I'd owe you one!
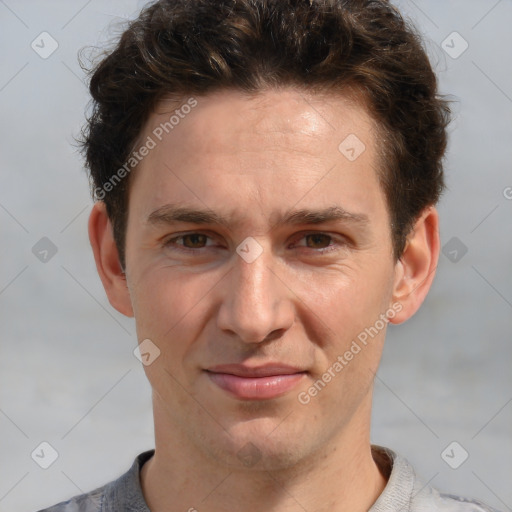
[389,206,440,324]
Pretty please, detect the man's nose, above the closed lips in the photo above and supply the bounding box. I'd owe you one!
[217,240,295,343]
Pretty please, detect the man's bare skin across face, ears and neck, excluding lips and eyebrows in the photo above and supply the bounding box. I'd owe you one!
[89,89,439,511]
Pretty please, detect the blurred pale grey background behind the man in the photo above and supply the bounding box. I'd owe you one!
[0,0,512,512]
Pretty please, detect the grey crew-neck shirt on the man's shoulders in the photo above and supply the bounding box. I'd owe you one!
[35,446,498,512]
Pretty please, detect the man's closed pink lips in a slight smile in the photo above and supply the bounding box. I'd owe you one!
[205,364,307,400]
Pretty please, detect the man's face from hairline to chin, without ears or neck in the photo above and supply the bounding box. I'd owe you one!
[126,89,395,468]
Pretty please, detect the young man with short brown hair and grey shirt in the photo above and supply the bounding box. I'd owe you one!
[37,0,500,512]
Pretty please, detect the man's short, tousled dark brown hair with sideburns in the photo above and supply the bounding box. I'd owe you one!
[82,0,450,268]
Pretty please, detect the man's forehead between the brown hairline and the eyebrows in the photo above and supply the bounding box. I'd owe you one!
[130,89,383,232]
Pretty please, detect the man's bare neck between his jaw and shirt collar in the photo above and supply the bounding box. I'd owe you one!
[141,397,386,512]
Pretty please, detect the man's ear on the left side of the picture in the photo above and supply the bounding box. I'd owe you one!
[89,201,133,317]
